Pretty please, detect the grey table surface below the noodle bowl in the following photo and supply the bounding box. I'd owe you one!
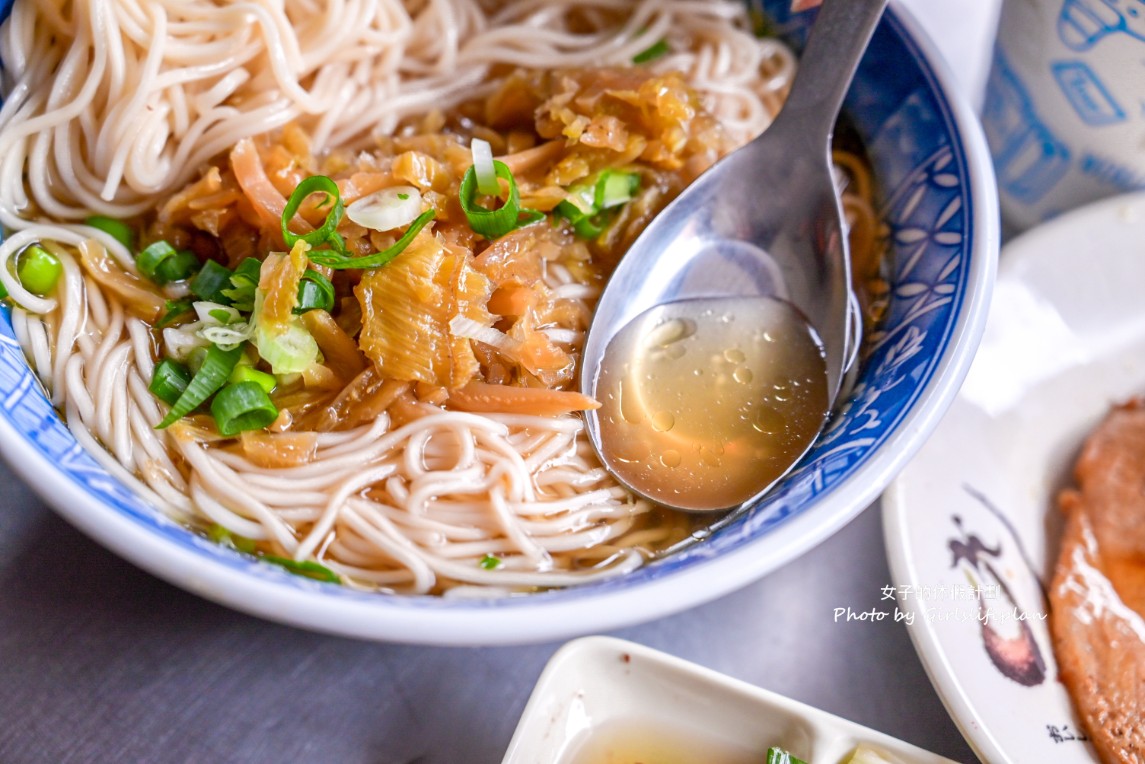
[0,449,976,764]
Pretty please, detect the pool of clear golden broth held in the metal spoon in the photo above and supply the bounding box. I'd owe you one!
[595,297,829,511]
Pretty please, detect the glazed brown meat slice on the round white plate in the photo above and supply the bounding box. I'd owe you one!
[1050,402,1145,764]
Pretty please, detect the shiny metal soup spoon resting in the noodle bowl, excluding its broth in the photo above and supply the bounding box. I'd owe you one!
[581,0,887,511]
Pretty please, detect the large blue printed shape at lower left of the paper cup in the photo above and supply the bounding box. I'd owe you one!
[982,53,1069,204]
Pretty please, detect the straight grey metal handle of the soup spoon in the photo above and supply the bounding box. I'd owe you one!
[775,0,887,140]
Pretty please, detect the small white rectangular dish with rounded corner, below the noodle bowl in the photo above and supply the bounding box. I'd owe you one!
[503,637,953,764]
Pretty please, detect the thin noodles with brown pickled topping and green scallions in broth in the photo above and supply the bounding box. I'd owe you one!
[0,0,882,593]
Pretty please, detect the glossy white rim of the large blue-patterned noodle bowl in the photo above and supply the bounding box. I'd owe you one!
[0,0,1000,646]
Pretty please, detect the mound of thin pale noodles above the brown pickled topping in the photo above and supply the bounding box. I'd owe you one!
[0,0,793,224]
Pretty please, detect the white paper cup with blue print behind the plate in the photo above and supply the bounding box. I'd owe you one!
[982,0,1145,229]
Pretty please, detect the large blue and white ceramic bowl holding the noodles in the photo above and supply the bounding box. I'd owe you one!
[0,0,998,645]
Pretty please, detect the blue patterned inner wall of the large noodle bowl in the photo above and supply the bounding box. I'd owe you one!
[0,0,993,632]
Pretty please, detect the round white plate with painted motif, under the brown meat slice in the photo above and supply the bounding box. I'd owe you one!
[884,195,1145,764]
